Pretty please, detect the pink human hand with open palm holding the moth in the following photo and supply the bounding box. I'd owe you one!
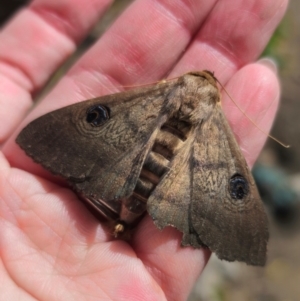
[0,0,287,301]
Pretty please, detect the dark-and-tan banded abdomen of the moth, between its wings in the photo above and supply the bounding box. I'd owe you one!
[120,118,192,224]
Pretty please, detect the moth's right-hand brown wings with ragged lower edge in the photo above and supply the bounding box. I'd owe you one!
[150,106,268,265]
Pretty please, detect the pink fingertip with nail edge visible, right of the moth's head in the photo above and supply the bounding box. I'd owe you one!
[223,59,280,166]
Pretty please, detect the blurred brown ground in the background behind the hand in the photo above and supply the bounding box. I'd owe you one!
[0,0,300,301]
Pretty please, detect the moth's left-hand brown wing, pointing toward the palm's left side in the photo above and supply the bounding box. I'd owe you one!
[17,82,177,200]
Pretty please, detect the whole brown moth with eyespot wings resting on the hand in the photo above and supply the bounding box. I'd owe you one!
[17,71,268,265]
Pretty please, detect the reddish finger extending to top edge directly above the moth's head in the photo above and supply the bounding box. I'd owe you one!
[172,0,288,78]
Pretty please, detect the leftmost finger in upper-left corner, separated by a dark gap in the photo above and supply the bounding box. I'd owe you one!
[0,0,111,143]
